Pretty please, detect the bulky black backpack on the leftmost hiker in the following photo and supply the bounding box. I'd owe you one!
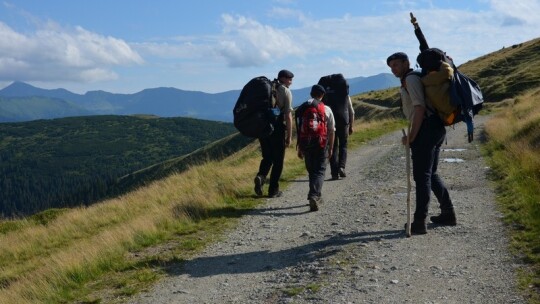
[233,76,280,138]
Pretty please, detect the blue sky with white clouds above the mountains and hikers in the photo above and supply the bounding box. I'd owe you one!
[0,0,540,93]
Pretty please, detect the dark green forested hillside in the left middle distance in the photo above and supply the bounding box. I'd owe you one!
[0,116,238,216]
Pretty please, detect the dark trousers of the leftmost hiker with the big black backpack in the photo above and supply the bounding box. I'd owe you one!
[257,123,285,193]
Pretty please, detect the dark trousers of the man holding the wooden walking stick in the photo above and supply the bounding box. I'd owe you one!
[411,115,454,222]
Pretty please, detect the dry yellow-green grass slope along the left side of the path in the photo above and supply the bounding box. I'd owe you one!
[0,120,401,303]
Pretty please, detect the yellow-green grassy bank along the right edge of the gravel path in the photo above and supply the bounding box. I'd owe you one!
[485,89,540,303]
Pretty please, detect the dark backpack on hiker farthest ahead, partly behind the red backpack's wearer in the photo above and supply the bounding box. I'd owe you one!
[318,74,349,126]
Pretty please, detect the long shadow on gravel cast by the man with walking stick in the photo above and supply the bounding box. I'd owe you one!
[163,230,405,277]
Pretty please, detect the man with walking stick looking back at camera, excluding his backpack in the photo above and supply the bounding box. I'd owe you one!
[386,52,456,234]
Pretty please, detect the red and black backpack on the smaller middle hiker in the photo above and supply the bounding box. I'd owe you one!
[294,99,328,151]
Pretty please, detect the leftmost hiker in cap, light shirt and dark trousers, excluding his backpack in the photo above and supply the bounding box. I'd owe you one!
[254,70,294,198]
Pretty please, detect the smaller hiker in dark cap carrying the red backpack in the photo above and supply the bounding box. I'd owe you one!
[295,84,335,211]
